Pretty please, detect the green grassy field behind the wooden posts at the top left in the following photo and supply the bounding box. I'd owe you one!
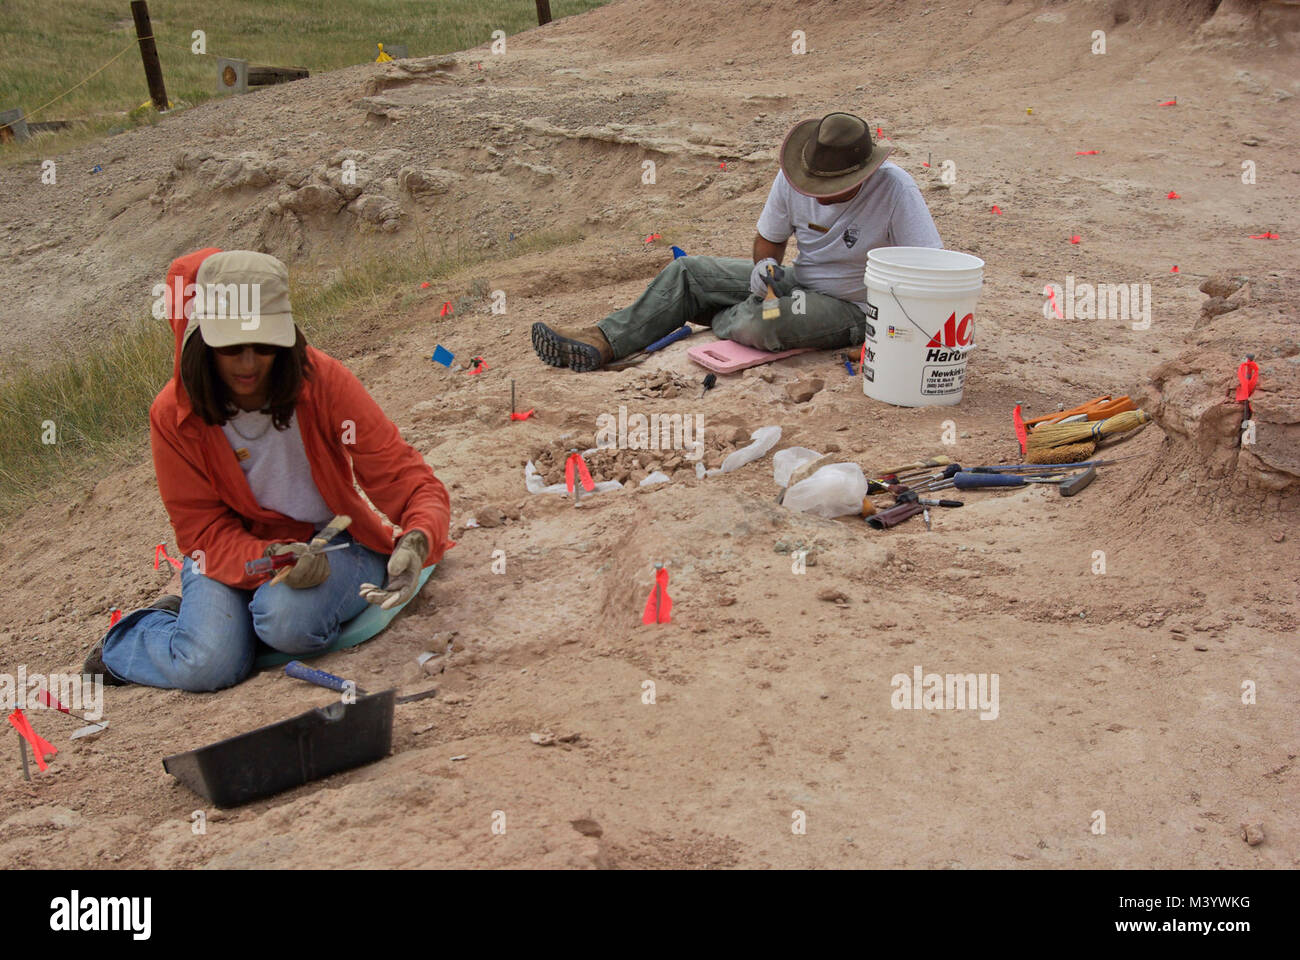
[0,0,606,163]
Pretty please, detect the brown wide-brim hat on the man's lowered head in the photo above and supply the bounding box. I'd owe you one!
[780,113,893,199]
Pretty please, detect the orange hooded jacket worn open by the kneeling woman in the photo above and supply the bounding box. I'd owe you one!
[150,247,451,589]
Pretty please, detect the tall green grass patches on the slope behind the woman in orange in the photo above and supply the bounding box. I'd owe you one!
[0,223,582,523]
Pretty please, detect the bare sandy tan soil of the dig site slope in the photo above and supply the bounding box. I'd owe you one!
[0,0,1300,868]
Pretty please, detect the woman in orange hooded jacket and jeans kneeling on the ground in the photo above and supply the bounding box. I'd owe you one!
[83,248,450,691]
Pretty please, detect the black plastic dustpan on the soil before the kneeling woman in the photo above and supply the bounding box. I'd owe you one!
[163,689,395,807]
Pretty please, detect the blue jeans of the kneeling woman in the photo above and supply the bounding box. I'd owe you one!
[103,531,389,691]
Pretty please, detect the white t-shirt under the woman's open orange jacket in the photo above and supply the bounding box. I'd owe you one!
[221,410,334,528]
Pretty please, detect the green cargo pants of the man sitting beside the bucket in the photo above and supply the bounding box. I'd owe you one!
[597,256,867,359]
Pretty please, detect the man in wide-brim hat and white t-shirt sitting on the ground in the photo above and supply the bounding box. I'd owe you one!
[533,113,944,372]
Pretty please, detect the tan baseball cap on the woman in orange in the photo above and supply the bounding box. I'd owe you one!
[182,250,298,347]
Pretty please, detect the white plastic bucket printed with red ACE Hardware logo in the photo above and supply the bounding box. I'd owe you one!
[862,247,984,407]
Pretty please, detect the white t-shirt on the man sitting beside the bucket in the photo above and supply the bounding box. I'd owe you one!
[758,160,944,306]
